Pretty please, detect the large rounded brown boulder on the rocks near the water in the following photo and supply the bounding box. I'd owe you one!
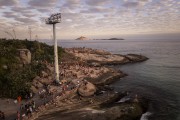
[78,82,96,97]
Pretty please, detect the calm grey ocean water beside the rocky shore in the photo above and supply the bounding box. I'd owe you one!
[49,39,180,120]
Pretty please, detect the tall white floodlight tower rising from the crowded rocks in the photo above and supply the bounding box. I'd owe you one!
[45,13,61,84]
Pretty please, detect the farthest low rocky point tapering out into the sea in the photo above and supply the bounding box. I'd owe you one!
[66,48,148,66]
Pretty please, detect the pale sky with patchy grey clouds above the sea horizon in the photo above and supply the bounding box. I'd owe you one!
[0,0,180,39]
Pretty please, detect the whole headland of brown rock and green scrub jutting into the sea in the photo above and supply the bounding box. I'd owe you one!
[0,40,148,120]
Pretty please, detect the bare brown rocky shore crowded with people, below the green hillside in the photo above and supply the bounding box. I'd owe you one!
[0,48,148,120]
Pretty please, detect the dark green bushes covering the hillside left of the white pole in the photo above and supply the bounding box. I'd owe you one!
[0,39,64,98]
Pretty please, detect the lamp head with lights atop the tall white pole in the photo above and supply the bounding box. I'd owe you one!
[45,13,61,24]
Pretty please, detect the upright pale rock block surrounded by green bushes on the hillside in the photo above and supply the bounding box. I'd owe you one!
[18,49,31,65]
